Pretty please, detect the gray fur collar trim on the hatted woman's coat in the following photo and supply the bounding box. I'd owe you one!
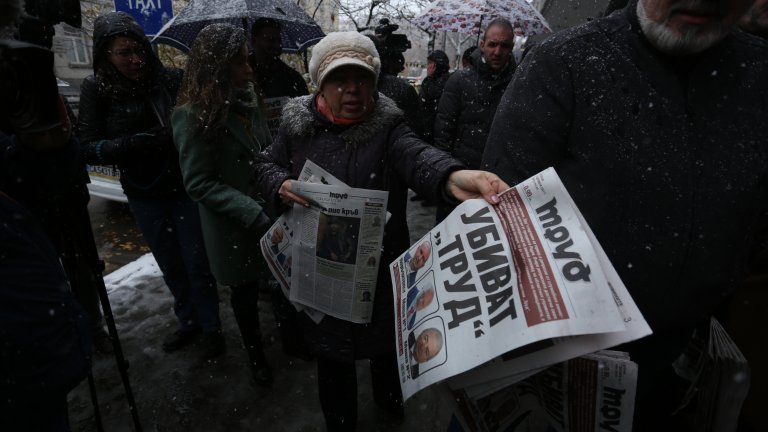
[280,93,404,146]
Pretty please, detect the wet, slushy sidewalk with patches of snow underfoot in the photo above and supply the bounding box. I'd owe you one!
[69,194,453,432]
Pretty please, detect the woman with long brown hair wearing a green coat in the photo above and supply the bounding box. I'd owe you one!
[171,24,272,385]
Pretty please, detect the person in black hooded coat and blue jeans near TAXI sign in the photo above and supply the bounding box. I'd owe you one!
[79,12,224,358]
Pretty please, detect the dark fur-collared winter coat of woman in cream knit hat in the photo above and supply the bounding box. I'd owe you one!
[255,96,462,362]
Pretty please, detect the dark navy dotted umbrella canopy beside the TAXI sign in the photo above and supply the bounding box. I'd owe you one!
[152,0,325,53]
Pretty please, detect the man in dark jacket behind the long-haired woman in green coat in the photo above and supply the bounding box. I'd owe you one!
[249,18,309,137]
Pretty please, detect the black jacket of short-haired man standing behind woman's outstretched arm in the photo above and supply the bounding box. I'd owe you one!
[434,49,517,169]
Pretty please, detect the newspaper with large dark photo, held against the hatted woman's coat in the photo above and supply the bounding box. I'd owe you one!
[284,181,388,323]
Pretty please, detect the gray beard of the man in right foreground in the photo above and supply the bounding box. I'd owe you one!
[637,0,730,55]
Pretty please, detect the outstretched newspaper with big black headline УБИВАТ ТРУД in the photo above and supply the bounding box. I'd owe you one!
[390,168,651,399]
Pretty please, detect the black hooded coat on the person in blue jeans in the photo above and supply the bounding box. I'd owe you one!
[78,14,184,198]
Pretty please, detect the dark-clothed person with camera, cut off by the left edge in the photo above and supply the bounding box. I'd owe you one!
[0,31,92,431]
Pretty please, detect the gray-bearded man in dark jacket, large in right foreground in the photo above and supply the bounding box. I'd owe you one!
[483,0,768,430]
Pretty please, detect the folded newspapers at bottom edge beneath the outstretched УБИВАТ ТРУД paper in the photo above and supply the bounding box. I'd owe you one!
[453,351,637,432]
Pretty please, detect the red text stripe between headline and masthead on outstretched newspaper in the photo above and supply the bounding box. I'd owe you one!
[496,188,568,327]
